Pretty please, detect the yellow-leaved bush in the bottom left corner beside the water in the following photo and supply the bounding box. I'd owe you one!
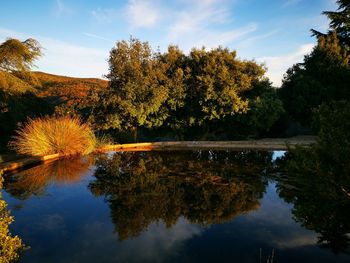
[0,171,23,263]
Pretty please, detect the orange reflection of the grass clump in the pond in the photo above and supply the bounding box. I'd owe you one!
[4,157,93,200]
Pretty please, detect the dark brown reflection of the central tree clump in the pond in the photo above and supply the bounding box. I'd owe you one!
[90,151,271,239]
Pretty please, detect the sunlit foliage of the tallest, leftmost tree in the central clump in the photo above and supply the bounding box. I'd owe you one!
[99,38,169,132]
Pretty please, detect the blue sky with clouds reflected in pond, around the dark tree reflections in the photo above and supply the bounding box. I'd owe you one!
[4,151,349,263]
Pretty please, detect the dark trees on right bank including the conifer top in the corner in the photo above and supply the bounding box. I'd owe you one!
[279,0,350,127]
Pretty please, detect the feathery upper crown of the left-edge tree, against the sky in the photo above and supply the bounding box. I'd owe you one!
[0,38,42,72]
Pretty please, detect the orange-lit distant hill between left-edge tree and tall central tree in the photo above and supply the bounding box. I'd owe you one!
[32,72,108,105]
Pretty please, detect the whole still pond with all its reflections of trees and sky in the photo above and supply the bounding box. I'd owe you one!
[3,151,350,263]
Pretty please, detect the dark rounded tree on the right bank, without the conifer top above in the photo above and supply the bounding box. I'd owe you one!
[280,33,350,125]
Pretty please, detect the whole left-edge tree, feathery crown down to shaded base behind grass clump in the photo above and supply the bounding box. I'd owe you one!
[0,38,52,145]
